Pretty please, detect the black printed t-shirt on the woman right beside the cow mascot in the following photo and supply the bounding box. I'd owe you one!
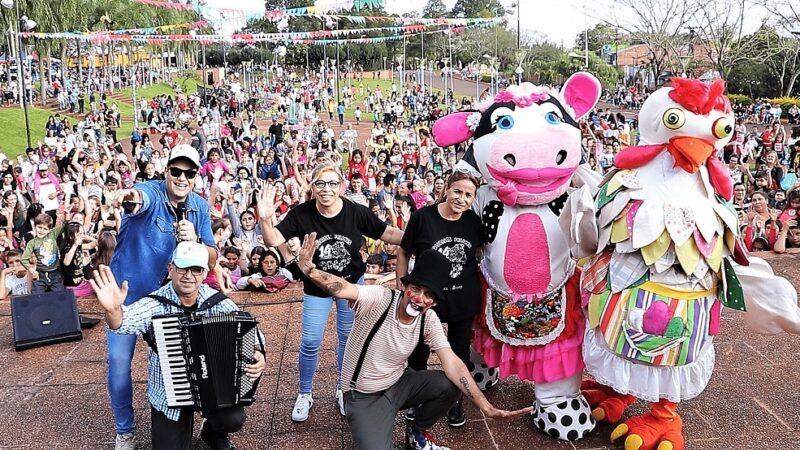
[400,205,483,322]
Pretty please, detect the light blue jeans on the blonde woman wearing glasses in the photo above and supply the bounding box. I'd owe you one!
[299,290,356,394]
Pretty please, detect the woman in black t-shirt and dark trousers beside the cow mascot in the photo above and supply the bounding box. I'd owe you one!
[397,172,483,427]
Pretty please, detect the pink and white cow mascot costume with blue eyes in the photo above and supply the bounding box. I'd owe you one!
[433,73,601,440]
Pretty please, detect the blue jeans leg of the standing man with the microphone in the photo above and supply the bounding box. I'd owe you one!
[106,330,139,434]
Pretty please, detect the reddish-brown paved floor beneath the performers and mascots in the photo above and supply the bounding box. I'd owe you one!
[0,251,800,450]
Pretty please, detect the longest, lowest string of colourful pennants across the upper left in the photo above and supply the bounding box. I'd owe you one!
[20,19,500,45]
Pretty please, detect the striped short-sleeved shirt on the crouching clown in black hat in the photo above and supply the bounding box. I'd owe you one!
[342,284,450,394]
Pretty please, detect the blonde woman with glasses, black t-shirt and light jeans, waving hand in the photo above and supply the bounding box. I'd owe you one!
[258,163,403,422]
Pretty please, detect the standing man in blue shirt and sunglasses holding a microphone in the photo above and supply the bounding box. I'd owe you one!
[106,144,217,450]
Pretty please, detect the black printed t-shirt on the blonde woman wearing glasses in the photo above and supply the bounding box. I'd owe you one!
[276,199,386,297]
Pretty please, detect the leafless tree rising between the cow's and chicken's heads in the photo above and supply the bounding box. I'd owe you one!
[602,0,697,86]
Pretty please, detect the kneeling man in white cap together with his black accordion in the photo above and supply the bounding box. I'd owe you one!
[90,241,265,449]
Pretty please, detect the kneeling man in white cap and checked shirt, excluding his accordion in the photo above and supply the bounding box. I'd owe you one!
[89,242,265,450]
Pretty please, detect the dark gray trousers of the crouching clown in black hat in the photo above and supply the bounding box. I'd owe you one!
[344,369,461,450]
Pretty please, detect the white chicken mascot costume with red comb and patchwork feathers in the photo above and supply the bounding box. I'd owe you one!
[560,78,800,450]
